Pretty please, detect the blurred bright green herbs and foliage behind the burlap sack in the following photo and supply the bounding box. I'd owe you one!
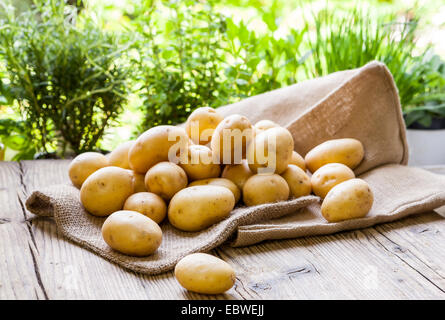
[0,0,445,160]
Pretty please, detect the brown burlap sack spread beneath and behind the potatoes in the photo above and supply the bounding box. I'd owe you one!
[26,62,445,274]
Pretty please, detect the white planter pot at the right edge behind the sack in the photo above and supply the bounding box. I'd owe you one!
[406,129,445,166]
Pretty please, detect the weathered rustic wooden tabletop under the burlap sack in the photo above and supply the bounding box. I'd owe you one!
[0,160,445,299]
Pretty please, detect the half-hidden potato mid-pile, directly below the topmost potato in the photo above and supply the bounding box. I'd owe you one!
[179,145,221,180]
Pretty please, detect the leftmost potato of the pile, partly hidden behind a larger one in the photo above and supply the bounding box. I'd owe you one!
[68,152,108,188]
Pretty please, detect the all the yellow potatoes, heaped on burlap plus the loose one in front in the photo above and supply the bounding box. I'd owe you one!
[69,108,373,293]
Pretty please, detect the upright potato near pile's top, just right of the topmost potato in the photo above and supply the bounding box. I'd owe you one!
[210,114,253,164]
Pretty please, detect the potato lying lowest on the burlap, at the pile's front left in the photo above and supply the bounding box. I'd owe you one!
[102,210,162,257]
